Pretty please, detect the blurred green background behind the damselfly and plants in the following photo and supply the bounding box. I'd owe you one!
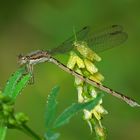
[0,0,140,140]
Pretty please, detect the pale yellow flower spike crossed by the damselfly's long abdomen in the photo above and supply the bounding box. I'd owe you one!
[67,41,107,139]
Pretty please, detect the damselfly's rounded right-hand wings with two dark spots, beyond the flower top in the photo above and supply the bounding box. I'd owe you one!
[85,25,128,52]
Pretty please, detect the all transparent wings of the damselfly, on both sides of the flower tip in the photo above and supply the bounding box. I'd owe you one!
[50,25,128,54]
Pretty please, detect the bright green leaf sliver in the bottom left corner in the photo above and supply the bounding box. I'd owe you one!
[0,120,7,140]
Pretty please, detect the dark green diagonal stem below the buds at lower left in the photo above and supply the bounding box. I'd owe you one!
[18,125,44,140]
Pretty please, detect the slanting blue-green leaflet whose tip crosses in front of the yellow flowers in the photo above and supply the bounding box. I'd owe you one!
[53,94,103,128]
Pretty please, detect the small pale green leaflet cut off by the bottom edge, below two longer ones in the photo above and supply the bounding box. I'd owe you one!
[45,131,60,140]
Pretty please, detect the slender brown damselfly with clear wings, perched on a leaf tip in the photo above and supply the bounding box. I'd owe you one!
[19,25,140,107]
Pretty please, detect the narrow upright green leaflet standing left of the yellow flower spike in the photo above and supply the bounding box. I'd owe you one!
[45,86,59,129]
